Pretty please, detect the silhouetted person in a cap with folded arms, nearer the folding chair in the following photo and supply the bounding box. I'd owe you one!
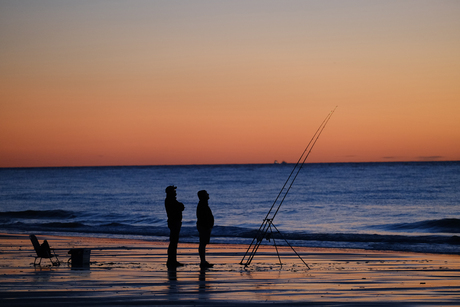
[165,186,185,268]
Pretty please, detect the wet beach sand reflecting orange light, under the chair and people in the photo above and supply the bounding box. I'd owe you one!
[0,233,460,306]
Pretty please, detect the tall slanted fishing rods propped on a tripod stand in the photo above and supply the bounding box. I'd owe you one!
[240,107,337,268]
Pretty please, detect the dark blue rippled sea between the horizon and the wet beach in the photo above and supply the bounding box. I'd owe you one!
[0,162,460,254]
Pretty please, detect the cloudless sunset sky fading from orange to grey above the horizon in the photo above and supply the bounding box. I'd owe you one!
[0,0,460,167]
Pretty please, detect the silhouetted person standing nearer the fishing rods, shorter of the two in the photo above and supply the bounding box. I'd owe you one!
[196,190,214,268]
